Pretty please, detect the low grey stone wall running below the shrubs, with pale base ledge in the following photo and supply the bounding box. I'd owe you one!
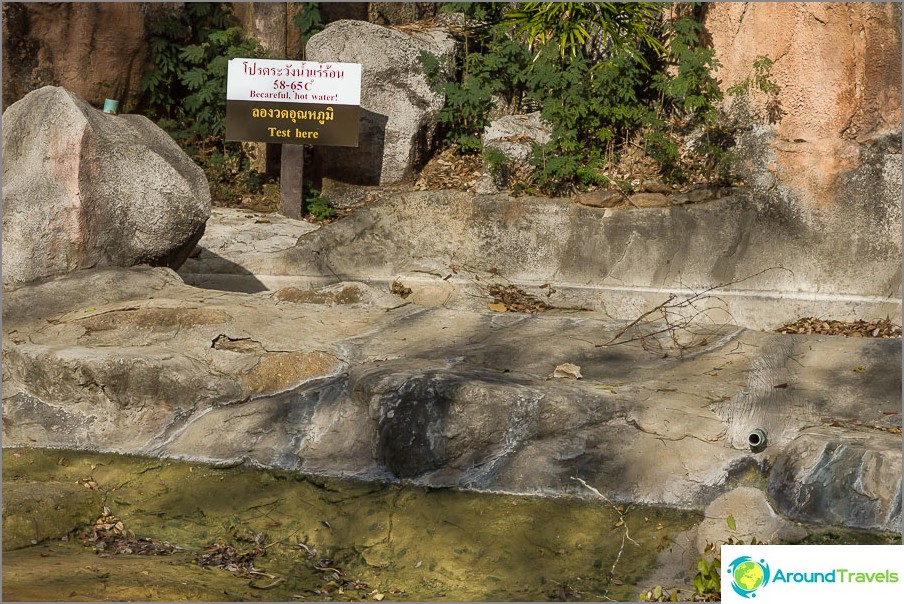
[175,190,901,329]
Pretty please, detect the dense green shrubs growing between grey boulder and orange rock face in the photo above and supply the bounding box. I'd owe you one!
[422,2,732,194]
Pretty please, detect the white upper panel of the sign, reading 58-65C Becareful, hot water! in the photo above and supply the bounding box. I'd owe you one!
[226,59,361,105]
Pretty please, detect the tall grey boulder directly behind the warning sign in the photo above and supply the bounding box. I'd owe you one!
[306,21,455,185]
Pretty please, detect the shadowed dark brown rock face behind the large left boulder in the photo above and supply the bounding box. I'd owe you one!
[3,2,149,112]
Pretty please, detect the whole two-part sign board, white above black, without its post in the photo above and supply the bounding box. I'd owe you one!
[226,59,361,147]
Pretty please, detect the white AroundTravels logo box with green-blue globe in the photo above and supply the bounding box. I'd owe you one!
[721,545,904,604]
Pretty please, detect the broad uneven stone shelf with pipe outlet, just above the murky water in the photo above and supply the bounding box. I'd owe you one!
[3,266,901,531]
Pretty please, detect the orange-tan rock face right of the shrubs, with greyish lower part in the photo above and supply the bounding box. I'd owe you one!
[705,2,901,218]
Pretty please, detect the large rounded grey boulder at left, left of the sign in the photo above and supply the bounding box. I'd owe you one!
[3,86,210,282]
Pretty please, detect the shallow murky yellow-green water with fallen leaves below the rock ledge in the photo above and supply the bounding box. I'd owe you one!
[3,449,700,601]
